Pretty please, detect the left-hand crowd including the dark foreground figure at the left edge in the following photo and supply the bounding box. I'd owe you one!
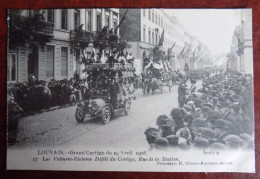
[7,78,89,144]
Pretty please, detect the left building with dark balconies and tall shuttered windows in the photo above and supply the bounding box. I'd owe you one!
[7,8,119,82]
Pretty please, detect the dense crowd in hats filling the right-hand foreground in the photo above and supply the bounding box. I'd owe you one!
[145,73,254,150]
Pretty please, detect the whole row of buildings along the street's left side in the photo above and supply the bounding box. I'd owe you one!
[7,8,210,82]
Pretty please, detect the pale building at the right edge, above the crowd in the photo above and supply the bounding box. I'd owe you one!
[226,9,253,74]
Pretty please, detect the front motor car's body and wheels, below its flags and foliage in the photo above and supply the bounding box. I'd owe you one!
[75,63,134,124]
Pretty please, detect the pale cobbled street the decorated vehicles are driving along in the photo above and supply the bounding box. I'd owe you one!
[10,82,199,148]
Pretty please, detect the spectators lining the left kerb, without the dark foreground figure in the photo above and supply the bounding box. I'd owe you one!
[8,78,87,113]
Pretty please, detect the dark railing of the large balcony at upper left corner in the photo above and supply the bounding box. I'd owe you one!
[9,13,54,36]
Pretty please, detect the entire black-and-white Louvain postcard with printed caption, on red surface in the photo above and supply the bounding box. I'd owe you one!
[6,8,255,173]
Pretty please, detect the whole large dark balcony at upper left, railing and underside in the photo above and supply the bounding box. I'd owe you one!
[9,13,54,43]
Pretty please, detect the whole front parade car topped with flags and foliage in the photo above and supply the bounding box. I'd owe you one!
[75,27,135,124]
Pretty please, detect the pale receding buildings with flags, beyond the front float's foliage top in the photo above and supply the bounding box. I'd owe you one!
[119,9,209,73]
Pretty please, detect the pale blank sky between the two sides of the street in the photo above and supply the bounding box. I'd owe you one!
[165,9,241,55]
